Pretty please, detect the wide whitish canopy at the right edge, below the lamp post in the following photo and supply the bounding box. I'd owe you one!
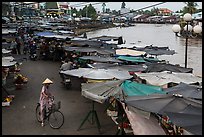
[136,71,202,86]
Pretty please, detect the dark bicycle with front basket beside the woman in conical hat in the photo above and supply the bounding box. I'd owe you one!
[36,98,64,129]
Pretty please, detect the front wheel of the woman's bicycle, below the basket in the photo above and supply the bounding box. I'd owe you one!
[48,110,64,129]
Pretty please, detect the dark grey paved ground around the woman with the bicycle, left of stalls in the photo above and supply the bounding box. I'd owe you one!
[2,56,117,135]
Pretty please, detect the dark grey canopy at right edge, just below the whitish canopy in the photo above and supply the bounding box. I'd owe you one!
[164,82,202,99]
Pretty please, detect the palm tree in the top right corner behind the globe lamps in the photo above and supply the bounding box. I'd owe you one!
[183,2,198,15]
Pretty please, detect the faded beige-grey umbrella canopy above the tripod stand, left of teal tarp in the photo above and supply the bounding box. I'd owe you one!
[81,80,123,103]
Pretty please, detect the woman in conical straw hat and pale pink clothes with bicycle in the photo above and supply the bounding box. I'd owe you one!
[39,78,53,126]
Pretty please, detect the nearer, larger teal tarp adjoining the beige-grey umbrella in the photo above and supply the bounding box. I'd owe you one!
[121,80,166,96]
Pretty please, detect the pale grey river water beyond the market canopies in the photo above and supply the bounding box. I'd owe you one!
[87,24,202,77]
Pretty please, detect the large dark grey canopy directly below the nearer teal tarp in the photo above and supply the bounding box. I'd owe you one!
[125,94,202,115]
